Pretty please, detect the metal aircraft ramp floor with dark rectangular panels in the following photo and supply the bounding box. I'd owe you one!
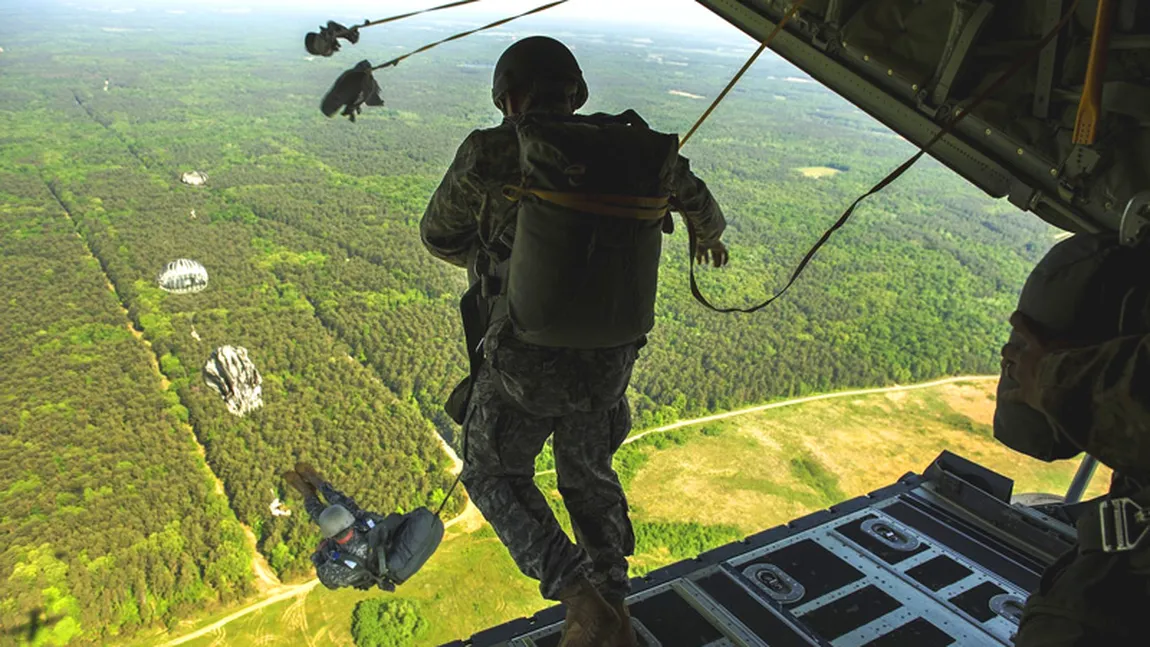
[447,453,1074,647]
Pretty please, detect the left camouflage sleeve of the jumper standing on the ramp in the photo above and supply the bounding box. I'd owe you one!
[420,131,484,268]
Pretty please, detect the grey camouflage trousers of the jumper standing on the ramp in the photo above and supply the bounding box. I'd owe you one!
[462,326,638,600]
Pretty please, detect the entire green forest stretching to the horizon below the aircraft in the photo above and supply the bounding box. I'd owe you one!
[0,2,1056,645]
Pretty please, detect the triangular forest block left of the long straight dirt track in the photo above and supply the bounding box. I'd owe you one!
[0,165,252,645]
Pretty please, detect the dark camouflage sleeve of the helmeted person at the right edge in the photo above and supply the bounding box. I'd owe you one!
[1037,336,1150,472]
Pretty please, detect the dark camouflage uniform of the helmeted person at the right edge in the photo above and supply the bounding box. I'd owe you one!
[1014,336,1150,647]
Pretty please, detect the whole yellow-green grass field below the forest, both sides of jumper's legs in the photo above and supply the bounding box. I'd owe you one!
[155,382,1109,647]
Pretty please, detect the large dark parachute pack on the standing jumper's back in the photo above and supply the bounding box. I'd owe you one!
[503,110,679,348]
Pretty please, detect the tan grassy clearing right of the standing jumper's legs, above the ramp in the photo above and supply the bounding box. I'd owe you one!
[628,382,1109,533]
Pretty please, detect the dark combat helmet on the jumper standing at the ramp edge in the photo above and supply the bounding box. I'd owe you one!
[491,36,588,110]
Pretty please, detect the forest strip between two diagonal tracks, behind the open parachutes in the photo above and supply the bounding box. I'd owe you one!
[24,107,460,577]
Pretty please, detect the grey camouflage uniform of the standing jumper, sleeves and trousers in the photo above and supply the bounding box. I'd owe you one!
[421,112,726,600]
